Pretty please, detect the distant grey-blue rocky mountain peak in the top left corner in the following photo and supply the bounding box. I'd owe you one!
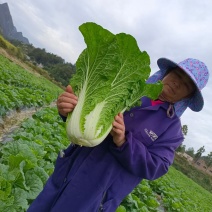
[0,3,29,44]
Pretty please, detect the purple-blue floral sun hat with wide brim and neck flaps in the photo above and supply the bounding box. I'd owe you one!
[147,58,209,117]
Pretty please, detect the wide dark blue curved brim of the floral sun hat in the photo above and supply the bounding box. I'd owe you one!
[157,58,204,112]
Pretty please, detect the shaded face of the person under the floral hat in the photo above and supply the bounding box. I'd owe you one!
[159,68,196,103]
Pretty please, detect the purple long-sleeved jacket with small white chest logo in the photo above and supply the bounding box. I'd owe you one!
[28,97,183,212]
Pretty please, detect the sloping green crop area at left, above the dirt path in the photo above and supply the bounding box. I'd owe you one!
[0,55,61,117]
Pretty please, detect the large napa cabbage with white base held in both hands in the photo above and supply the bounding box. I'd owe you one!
[66,22,162,147]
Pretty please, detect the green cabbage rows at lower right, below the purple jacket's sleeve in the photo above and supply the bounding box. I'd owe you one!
[116,167,212,212]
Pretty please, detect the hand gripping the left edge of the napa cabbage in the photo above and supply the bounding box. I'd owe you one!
[57,85,78,117]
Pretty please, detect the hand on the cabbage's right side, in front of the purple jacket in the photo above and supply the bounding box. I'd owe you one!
[111,113,125,147]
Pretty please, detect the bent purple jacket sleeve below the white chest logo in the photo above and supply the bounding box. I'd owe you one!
[110,132,183,180]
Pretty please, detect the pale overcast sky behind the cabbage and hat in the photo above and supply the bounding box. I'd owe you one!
[0,0,212,155]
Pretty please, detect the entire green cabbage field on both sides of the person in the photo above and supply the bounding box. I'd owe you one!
[0,53,212,212]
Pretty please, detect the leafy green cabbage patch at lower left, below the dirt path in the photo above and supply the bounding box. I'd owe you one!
[0,108,68,212]
